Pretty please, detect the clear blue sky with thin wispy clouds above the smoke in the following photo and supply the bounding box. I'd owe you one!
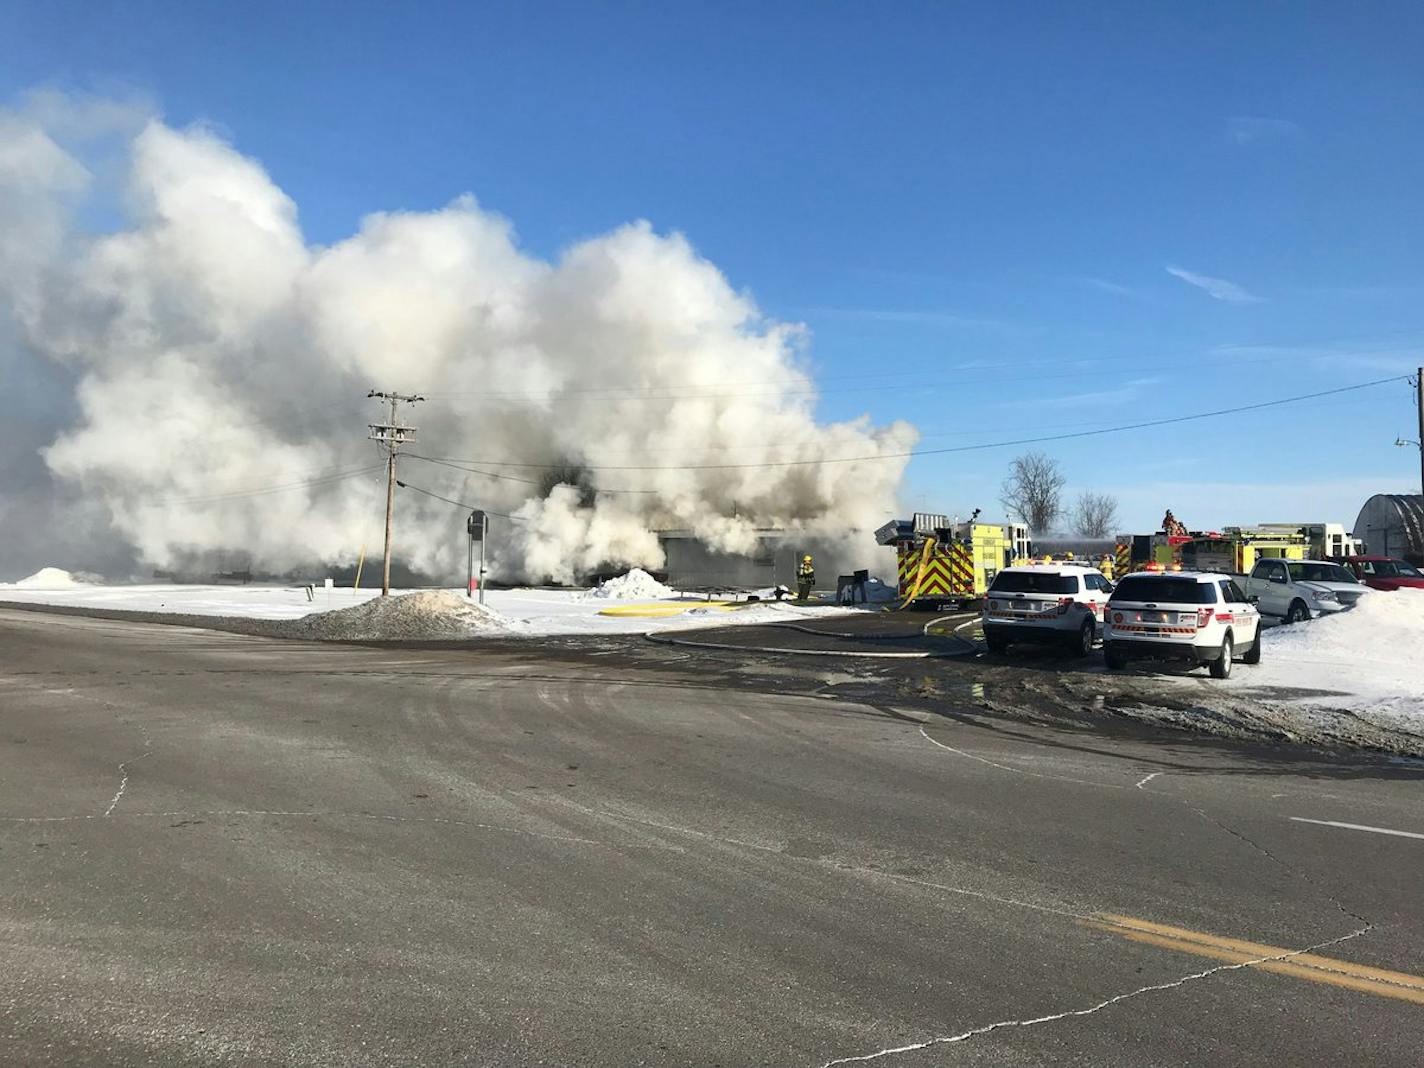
[0,1,1424,530]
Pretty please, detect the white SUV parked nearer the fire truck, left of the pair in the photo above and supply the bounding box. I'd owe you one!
[981,564,1112,656]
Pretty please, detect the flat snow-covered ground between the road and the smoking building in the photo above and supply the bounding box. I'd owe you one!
[0,584,863,637]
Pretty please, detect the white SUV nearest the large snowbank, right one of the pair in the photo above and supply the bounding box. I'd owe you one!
[1102,571,1260,679]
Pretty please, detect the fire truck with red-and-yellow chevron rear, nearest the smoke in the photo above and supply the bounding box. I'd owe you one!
[876,510,1030,608]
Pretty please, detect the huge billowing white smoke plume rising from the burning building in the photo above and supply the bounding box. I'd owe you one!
[0,98,917,581]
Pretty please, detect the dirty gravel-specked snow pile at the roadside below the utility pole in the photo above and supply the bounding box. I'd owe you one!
[283,590,510,641]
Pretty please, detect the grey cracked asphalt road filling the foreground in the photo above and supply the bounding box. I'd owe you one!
[0,611,1424,1068]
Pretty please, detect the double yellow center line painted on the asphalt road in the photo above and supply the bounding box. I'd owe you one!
[1084,914,1424,1005]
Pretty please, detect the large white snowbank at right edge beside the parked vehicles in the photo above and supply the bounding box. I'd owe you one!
[1233,590,1424,726]
